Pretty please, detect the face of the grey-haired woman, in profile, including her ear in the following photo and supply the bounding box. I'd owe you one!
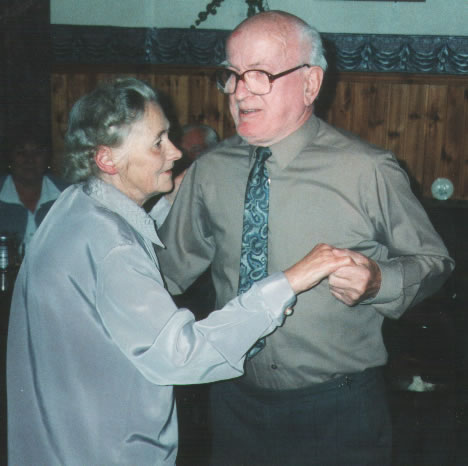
[111,104,182,205]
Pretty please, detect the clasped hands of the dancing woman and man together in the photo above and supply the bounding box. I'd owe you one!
[284,244,382,306]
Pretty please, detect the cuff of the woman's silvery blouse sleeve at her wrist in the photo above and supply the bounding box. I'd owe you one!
[257,272,296,325]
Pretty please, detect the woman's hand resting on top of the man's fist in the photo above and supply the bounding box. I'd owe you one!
[284,244,355,294]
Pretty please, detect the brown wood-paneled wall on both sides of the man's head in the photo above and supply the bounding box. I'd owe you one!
[51,65,468,200]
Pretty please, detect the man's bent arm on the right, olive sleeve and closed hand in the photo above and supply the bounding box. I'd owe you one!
[329,157,454,318]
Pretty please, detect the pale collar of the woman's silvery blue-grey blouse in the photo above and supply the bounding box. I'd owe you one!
[83,177,164,247]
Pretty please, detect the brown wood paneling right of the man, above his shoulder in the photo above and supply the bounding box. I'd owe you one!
[325,73,468,199]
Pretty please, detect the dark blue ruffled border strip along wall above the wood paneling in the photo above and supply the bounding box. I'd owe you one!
[52,25,468,74]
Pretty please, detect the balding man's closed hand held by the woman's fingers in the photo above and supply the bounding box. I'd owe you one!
[328,249,382,306]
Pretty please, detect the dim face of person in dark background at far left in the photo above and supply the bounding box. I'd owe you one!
[10,142,49,185]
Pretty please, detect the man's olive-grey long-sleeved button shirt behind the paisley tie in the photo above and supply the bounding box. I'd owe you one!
[159,116,454,390]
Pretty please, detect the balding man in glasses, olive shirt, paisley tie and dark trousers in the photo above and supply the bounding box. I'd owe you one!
[160,11,454,466]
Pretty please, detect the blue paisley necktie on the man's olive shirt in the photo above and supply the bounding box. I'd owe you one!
[237,147,271,359]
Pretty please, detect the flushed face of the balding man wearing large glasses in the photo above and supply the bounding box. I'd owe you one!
[227,23,312,146]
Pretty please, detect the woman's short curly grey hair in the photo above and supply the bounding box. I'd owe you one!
[63,78,159,183]
